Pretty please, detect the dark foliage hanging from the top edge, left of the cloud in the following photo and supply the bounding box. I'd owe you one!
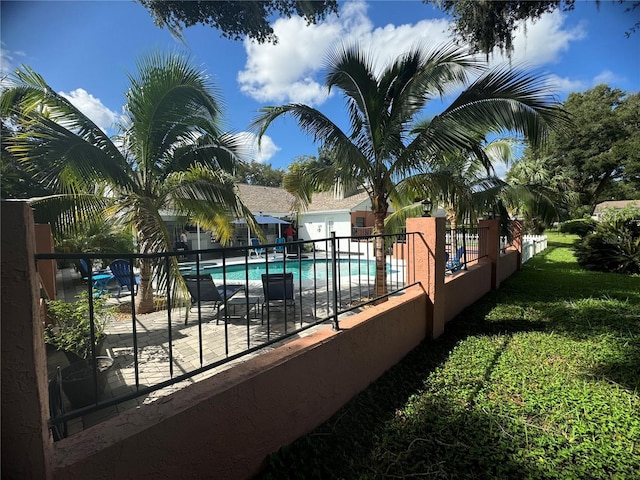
[137,0,338,43]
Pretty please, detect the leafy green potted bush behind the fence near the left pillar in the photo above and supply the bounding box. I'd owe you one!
[44,292,114,359]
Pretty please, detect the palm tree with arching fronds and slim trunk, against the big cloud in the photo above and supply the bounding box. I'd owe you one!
[253,45,564,295]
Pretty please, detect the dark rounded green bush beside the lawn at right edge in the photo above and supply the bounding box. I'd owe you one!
[575,208,640,273]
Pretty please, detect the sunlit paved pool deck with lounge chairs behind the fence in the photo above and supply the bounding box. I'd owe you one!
[48,259,350,435]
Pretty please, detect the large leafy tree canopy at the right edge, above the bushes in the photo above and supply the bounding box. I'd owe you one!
[525,85,640,216]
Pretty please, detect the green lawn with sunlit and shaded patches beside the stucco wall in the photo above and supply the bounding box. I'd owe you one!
[262,234,640,480]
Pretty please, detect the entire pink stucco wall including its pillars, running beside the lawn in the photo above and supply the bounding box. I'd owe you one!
[2,202,517,480]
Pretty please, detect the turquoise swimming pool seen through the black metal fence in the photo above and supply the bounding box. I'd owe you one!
[185,259,389,281]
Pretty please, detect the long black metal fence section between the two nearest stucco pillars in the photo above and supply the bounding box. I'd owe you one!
[41,233,416,439]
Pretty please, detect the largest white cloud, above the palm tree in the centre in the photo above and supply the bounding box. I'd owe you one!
[238,1,450,105]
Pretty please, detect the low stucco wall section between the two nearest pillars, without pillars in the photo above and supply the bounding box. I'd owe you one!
[54,286,428,480]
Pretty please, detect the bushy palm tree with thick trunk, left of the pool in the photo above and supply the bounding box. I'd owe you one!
[0,53,253,313]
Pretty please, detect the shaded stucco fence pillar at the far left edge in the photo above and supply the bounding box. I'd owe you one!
[1,201,53,479]
